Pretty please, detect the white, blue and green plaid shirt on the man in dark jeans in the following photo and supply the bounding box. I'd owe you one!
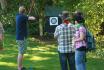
[54,23,75,53]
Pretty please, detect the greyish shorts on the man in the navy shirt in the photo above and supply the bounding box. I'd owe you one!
[16,39,27,54]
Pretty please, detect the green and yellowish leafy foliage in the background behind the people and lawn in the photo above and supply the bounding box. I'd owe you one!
[0,0,104,57]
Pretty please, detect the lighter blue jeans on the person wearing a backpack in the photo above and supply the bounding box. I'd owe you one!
[75,50,86,70]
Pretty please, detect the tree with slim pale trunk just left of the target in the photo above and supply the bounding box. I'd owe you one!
[29,0,52,36]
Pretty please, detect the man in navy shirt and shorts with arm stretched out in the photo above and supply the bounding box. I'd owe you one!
[16,6,35,70]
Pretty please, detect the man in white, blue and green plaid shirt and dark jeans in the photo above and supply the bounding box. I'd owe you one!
[54,11,75,70]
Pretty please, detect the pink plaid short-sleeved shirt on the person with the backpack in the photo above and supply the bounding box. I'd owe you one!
[75,26,86,49]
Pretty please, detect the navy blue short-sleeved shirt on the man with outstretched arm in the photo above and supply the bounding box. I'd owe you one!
[16,14,28,40]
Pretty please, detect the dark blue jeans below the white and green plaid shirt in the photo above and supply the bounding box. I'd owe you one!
[59,53,75,70]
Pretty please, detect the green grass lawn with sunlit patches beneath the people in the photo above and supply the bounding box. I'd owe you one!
[0,34,104,70]
